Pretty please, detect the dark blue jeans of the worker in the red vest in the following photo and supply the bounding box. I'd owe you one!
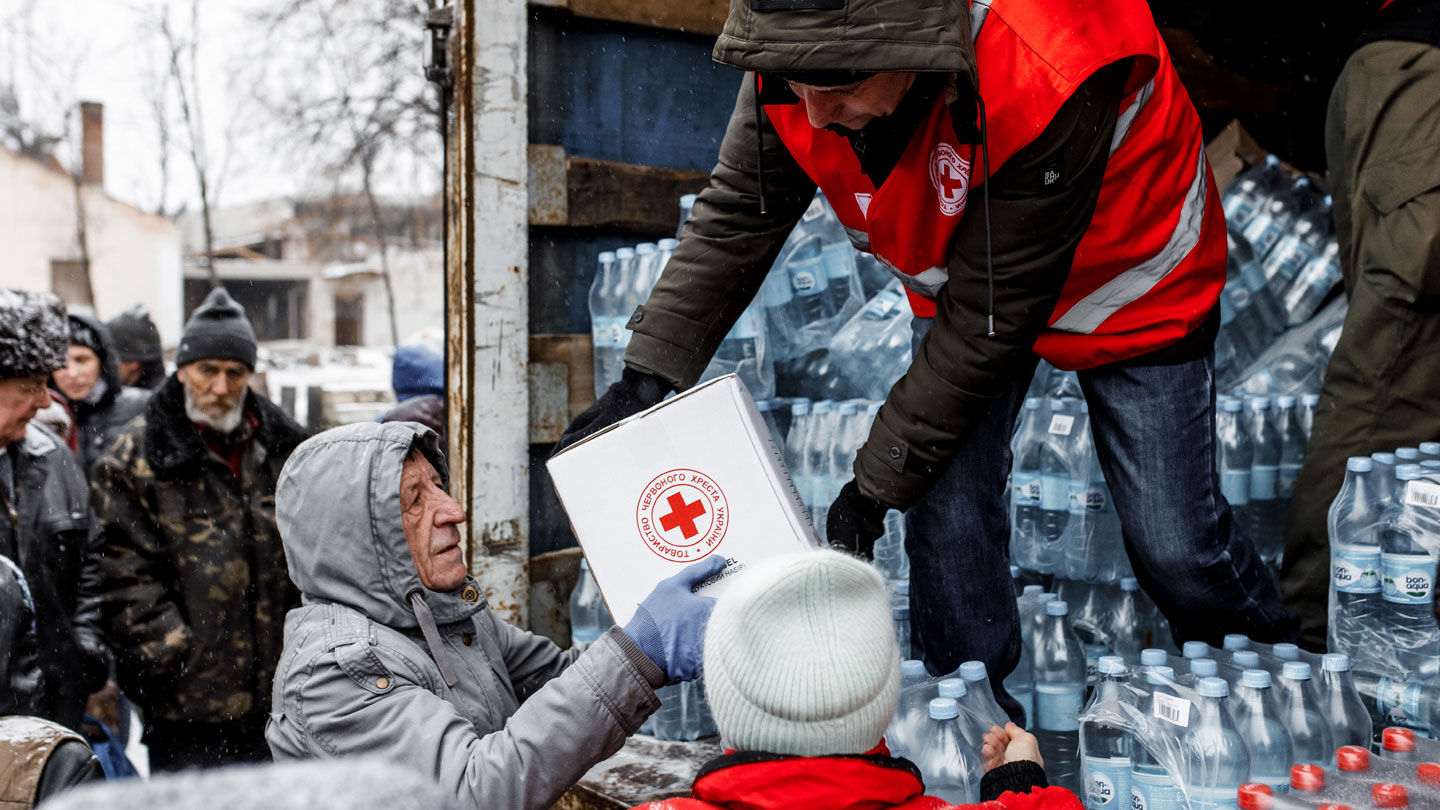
[906,319,1299,719]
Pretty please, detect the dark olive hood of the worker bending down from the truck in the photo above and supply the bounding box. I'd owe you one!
[713,0,984,88]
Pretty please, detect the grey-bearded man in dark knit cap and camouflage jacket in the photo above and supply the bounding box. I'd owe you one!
[91,288,305,771]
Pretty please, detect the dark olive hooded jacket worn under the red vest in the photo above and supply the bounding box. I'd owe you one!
[625,0,1218,509]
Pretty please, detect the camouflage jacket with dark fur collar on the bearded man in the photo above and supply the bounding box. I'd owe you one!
[91,376,305,722]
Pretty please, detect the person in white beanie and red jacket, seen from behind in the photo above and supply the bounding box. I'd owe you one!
[638,551,1081,810]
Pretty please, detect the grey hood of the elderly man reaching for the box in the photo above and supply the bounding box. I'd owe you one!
[275,422,485,628]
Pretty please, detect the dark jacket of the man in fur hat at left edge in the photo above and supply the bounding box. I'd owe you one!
[0,422,109,728]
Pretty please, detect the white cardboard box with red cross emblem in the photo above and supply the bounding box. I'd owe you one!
[546,375,819,626]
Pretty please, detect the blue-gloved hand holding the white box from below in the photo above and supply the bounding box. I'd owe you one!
[625,555,724,683]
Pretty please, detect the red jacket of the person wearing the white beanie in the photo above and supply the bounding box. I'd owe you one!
[635,748,1081,810]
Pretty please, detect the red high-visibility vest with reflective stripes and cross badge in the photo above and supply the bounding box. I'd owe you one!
[765,0,1225,369]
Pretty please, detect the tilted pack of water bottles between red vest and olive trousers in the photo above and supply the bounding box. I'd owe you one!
[1215,154,1341,395]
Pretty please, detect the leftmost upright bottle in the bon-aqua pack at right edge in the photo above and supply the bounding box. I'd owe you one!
[1326,455,1384,651]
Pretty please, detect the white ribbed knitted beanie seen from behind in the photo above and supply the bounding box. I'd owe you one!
[704,551,900,757]
